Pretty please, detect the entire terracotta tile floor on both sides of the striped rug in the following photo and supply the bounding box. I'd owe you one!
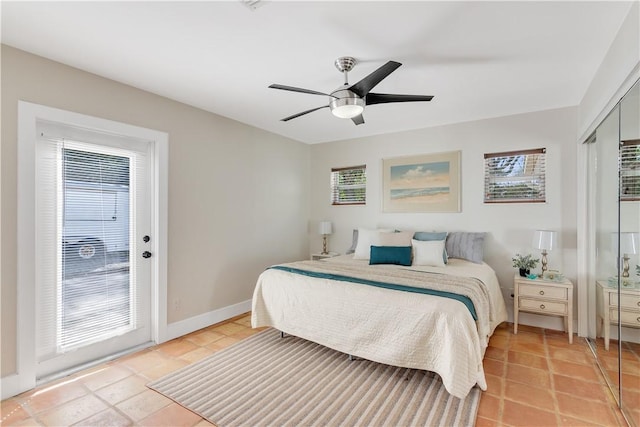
[0,315,640,426]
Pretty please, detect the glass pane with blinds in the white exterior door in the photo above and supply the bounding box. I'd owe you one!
[58,148,135,351]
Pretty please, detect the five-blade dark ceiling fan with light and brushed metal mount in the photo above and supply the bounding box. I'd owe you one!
[269,56,433,125]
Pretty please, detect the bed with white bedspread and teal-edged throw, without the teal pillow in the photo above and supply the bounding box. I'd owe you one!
[251,233,507,398]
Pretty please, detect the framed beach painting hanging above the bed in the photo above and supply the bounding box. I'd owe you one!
[382,151,460,212]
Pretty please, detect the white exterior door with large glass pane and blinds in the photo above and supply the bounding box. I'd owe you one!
[36,124,151,378]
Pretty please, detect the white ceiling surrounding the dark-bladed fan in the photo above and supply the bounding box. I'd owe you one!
[1,0,632,143]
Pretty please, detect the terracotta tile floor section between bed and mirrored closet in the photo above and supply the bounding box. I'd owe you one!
[476,323,640,427]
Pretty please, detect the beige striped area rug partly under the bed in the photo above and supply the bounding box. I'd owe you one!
[148,329,480,427]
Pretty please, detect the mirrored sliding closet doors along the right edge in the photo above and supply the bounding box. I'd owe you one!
[587,82,640,427]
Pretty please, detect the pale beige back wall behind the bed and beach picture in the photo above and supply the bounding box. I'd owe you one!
[310,107,577,328]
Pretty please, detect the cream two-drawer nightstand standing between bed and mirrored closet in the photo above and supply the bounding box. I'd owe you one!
[513,274,573,344]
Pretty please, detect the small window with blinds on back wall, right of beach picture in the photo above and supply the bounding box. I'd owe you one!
[484,148,546,203]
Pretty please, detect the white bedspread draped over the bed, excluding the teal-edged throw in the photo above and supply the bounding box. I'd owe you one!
[251,256,507,398]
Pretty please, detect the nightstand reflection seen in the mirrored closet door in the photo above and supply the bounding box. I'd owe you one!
[596,280,640,351]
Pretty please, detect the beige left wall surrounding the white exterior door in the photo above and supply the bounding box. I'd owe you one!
[0,45,310,377]
